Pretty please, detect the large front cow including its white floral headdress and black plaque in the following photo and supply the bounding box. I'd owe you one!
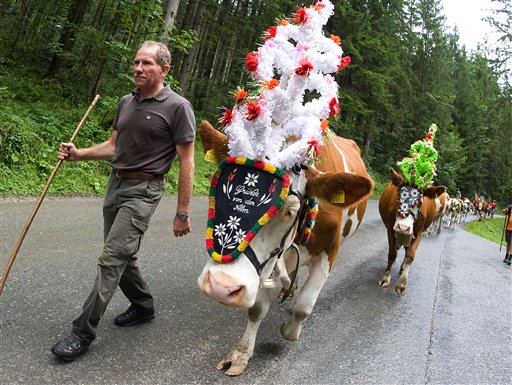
[194,0,373,376]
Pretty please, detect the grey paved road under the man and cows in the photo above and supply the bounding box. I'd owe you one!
[0,198,512,385]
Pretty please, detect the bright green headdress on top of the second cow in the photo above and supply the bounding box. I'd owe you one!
[397,123,437,189]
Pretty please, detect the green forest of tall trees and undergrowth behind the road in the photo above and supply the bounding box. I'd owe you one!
[0,0,512,205]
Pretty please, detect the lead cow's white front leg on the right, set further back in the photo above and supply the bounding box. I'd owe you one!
[281,248,329,341]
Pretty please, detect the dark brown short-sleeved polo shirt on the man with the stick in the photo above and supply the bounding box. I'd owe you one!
[111,86,195,174]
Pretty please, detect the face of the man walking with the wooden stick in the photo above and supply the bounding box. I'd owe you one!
[133,46,169,90]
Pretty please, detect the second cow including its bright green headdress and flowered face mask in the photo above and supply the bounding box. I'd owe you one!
[379,124,446,296]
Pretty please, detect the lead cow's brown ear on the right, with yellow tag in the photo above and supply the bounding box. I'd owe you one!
[306,172,374,207]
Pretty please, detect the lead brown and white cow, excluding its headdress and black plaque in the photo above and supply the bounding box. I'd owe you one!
[198,121,374,376]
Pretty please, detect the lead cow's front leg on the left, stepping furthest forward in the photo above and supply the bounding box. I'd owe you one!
[217,289,270,376]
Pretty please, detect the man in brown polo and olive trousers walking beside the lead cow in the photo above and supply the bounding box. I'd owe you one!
[51,41,195,361]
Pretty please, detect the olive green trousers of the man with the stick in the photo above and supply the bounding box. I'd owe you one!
[72,174,165,343]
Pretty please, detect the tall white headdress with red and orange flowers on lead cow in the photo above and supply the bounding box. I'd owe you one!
[219,0,350,169]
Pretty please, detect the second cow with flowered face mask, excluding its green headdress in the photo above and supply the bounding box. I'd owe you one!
[379,168,446,296]
